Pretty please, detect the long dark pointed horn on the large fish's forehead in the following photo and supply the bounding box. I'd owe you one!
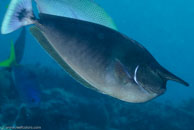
[159,67,189,86]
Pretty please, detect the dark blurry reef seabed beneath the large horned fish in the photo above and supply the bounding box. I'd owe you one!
[0,65,194,130]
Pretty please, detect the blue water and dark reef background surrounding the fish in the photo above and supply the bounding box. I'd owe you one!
[0,0,194,130]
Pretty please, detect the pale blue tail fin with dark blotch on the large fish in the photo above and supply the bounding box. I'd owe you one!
[1,0,35,34]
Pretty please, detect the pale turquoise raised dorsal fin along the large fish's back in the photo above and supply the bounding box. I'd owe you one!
[35,0,117,30]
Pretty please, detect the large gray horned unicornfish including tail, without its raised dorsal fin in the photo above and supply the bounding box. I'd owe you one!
[2,0,189,103]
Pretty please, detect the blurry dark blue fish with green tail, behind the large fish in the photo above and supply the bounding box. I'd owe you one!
[0,29,40,107]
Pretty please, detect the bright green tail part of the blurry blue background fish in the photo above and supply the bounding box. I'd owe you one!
[0,41,16,68]
